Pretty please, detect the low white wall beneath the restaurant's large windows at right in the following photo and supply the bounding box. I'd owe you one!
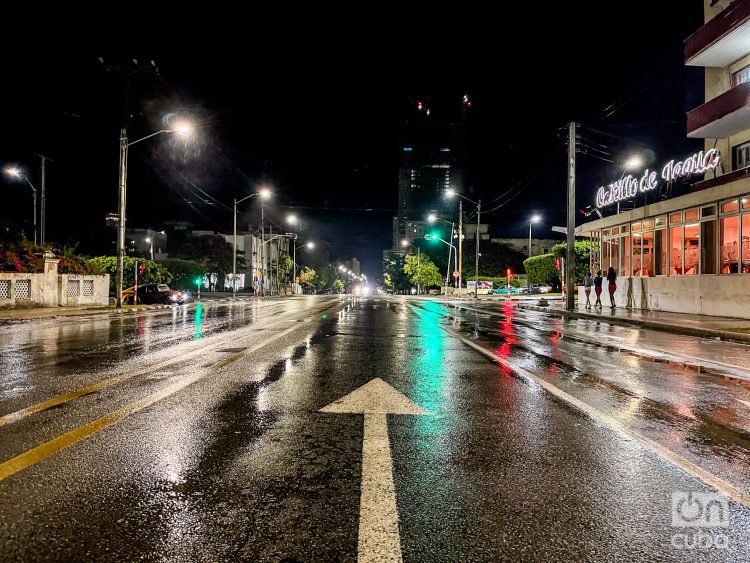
[578,274,750,319]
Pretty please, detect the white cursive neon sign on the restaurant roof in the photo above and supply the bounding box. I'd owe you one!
[596,149,721,208]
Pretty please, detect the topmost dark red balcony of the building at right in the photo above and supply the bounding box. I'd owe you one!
[685,0,750,68]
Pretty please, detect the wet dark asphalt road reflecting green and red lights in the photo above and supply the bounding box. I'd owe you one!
[0,296,750,561]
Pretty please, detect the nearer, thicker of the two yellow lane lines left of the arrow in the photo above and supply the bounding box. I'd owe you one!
[0,305,332,481]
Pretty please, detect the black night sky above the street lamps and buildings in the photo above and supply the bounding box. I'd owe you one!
[0,0,703,277]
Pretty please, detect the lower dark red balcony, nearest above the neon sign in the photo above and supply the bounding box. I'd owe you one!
[687,82,750,139]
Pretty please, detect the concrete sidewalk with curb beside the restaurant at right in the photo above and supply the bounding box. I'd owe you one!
[518,302,750,344]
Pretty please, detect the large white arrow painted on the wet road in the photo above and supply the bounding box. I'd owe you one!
[320,378,432,562]
